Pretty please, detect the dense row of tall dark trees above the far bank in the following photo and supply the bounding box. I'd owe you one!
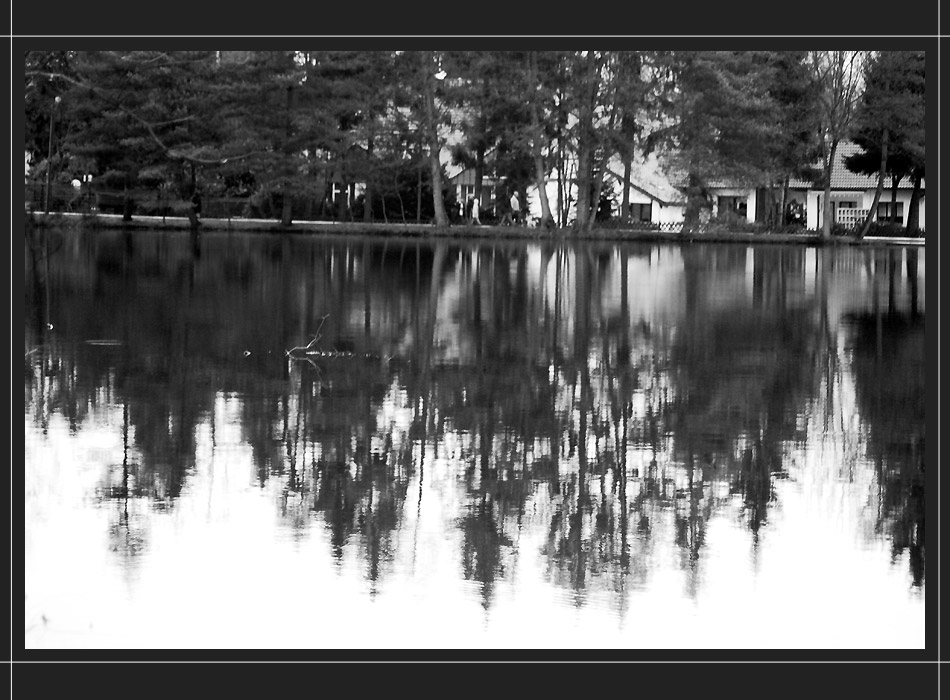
[25,51,924,234]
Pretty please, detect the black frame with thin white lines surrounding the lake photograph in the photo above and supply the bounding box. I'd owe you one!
[7,0,947,697]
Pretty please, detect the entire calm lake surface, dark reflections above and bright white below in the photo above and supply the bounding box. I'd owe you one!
[24,231,925,649]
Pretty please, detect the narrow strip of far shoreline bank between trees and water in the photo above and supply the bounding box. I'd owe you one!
[27,212,925,246]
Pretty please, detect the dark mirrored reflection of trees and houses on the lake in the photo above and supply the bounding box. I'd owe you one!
[25,232,924,644]
